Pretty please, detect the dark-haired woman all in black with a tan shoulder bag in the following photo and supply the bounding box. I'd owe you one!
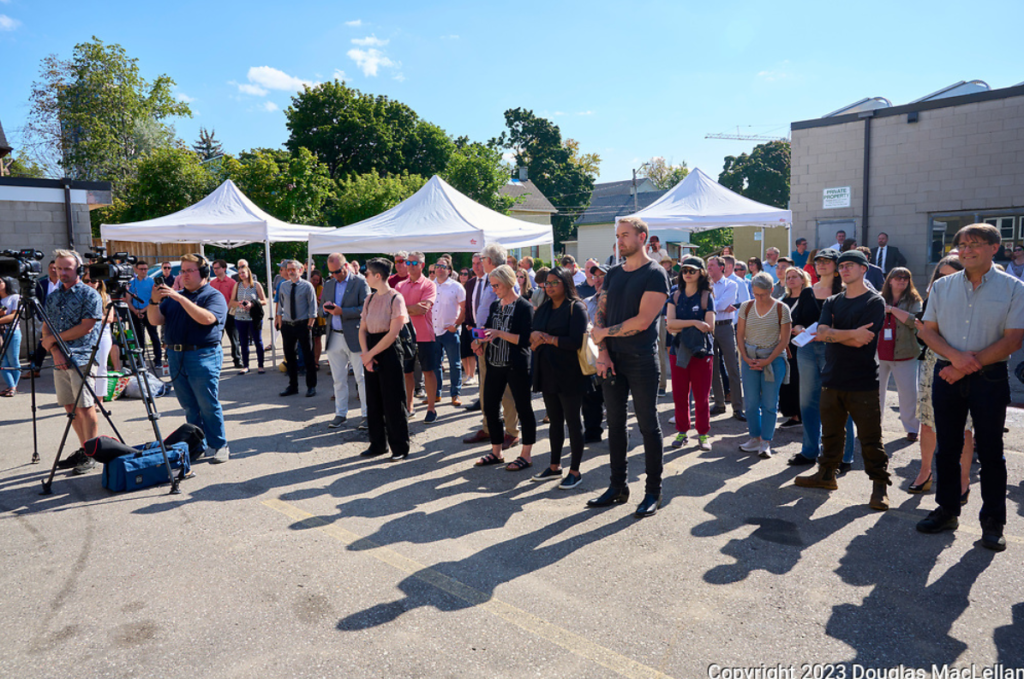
[529,266,592,489]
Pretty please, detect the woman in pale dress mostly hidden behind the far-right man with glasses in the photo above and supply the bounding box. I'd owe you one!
[906,255,974,505]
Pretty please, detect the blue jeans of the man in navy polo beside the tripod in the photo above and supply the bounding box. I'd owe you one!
[167,344,227,450]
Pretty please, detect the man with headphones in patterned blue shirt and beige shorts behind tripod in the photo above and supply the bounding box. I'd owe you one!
[43,250,103,474]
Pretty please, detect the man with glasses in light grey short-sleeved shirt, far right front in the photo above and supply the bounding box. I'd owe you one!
[918,224,1024,552]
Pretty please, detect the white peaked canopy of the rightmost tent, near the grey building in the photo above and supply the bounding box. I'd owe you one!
[615,168,793,231]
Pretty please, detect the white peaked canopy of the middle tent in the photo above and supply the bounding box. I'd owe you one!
[309,175,554,254]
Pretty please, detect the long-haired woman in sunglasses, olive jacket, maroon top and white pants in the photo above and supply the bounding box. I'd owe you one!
[879,266,922,442]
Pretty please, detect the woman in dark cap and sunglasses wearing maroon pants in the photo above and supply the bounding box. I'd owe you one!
[666,257,715,451]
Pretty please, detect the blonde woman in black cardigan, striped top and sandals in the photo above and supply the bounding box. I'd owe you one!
[473,264,537,471]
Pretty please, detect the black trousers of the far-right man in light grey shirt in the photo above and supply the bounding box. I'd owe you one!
[932,363,1010,524]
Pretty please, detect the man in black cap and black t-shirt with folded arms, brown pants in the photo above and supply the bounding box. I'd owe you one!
[795,250,889,510]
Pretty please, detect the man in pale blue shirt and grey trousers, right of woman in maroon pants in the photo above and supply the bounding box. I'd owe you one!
[708,255,746,422]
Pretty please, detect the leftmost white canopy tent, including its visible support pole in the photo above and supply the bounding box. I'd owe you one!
[99,179,323,362]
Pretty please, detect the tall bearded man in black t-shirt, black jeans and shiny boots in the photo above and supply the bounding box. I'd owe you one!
[587,217,669,517]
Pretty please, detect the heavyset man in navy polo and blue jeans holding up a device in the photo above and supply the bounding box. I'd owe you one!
[147,255,230,464]
